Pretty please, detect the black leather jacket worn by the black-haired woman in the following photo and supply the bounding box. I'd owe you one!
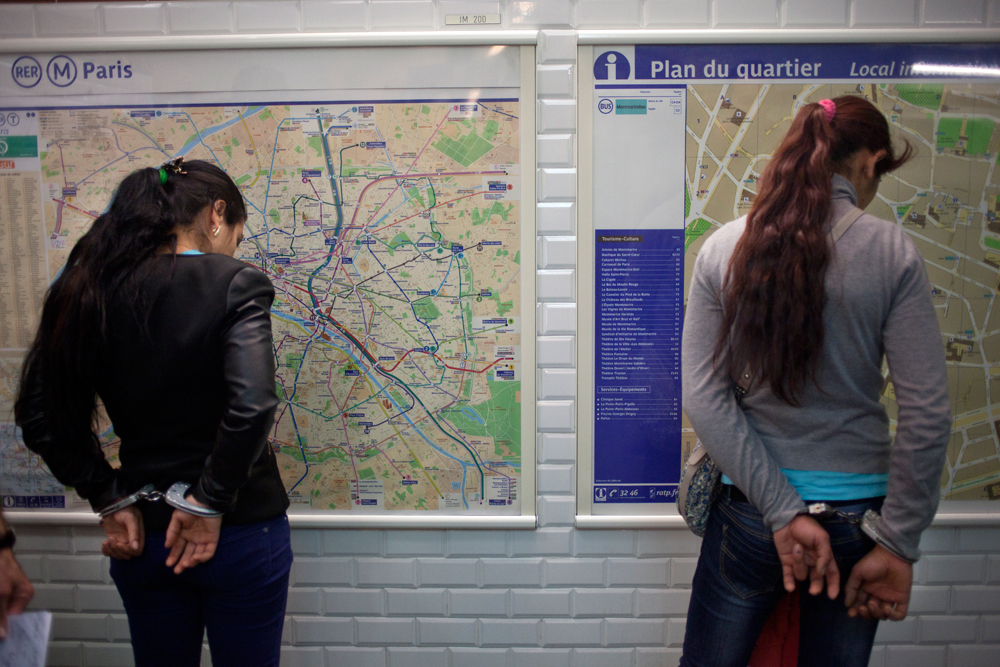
[20,254,288,529]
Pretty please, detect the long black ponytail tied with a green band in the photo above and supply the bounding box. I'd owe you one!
[14,160,246,442]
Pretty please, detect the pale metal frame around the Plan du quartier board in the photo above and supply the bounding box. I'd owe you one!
[575,28,1000,530]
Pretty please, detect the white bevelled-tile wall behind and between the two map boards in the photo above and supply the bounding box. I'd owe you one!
[0,0,1000,667]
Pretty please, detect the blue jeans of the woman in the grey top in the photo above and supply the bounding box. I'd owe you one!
[681,486,882,667]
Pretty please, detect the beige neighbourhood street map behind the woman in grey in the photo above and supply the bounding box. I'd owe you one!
[684,80,1000,500]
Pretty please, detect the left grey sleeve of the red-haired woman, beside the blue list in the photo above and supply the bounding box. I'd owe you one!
[681,235,805,531]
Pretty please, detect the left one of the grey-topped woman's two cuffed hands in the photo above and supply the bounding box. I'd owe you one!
[774,514,840,600]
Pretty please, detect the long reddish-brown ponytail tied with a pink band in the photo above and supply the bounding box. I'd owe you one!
[715,96,913,406]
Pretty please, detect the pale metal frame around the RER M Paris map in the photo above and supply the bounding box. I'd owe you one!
[0,36,539,530]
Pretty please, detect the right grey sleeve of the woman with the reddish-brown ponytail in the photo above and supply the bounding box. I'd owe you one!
[878,238,951,560]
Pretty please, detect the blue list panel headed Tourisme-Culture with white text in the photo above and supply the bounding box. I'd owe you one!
[594,229,684,503]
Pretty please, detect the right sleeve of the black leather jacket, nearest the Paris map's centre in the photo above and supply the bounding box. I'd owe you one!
[193,267,278,511]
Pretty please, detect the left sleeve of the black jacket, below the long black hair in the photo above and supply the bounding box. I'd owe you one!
[17,359,126,512]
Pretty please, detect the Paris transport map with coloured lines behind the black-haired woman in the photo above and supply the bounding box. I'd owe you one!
[0,99,531,514]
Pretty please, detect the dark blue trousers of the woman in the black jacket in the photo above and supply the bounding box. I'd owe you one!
[111,516,292,667]
